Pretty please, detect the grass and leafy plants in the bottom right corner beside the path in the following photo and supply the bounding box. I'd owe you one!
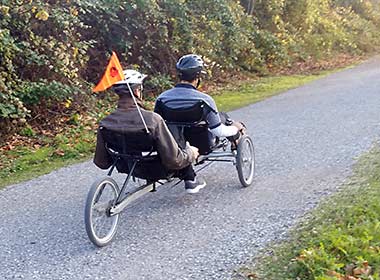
[236,144,380,280]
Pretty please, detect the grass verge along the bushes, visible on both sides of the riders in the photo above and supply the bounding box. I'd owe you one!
[0,70,348,188]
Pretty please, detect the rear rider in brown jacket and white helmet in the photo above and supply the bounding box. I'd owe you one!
[94,70,199,193]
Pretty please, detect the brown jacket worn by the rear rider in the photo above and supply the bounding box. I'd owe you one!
[94,96,195,170]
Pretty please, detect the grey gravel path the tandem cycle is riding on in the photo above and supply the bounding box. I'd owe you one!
[0,58,380,280]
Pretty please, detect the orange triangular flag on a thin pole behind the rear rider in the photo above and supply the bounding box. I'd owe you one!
[92,52,124,92]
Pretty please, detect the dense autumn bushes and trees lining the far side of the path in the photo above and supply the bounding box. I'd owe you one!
[0,0,380,140]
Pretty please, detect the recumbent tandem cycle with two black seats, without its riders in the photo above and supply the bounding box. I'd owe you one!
[85,100,255,247]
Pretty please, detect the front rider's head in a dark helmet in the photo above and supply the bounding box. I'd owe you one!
[176,54,205,87]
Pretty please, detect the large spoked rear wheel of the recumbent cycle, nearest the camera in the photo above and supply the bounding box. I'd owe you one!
[84,177,120,247]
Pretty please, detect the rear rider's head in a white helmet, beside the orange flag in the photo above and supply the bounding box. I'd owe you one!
[113,69,147,98]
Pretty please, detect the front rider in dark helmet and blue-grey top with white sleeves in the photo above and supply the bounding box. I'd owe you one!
[155,54,244,193]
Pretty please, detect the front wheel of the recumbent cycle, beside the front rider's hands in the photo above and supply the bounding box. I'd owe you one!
[236,135,255,187]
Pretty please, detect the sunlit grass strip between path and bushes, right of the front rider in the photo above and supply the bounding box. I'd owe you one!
[213,71,331,112]
